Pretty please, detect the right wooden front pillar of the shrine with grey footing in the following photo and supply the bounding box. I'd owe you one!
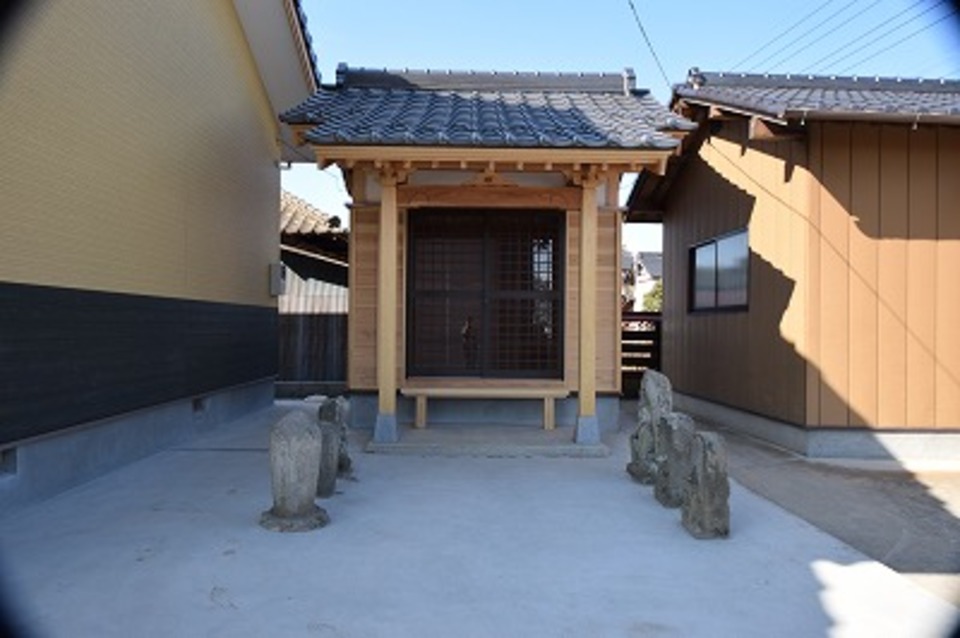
[576,177,600,444]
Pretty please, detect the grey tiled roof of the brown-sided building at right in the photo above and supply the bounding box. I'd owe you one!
[674,68,960,124]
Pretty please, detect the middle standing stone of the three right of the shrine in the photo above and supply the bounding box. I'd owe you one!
[653,412,696,507]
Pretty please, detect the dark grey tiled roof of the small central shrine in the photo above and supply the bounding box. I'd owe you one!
[281,65,694,149]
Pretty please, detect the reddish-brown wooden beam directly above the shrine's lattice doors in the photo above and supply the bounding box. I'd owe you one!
[397,185,580,210]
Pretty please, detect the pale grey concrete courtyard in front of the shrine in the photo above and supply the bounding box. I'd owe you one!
[0,404,958,637]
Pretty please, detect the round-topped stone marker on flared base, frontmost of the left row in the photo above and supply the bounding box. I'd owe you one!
[260,410,330,532]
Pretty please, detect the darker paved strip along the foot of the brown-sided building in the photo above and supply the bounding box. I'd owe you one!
[688,410,960,606]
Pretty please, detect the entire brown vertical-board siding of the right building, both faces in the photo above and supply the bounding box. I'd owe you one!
[664,121,960,429]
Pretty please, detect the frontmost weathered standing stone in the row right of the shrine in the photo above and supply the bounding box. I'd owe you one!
[682,432,730,538]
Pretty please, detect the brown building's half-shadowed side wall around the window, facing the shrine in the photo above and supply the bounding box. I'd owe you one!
[663,121,809,423]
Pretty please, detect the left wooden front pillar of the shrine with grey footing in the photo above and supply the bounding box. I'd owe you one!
[373,170,399,443]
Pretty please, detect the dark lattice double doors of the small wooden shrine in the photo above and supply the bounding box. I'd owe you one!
[407,209,565,378]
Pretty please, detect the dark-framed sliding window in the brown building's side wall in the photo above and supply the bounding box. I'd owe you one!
[690,229,750,311]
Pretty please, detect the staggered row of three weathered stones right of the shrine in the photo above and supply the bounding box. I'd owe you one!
[627,370,730,538]
